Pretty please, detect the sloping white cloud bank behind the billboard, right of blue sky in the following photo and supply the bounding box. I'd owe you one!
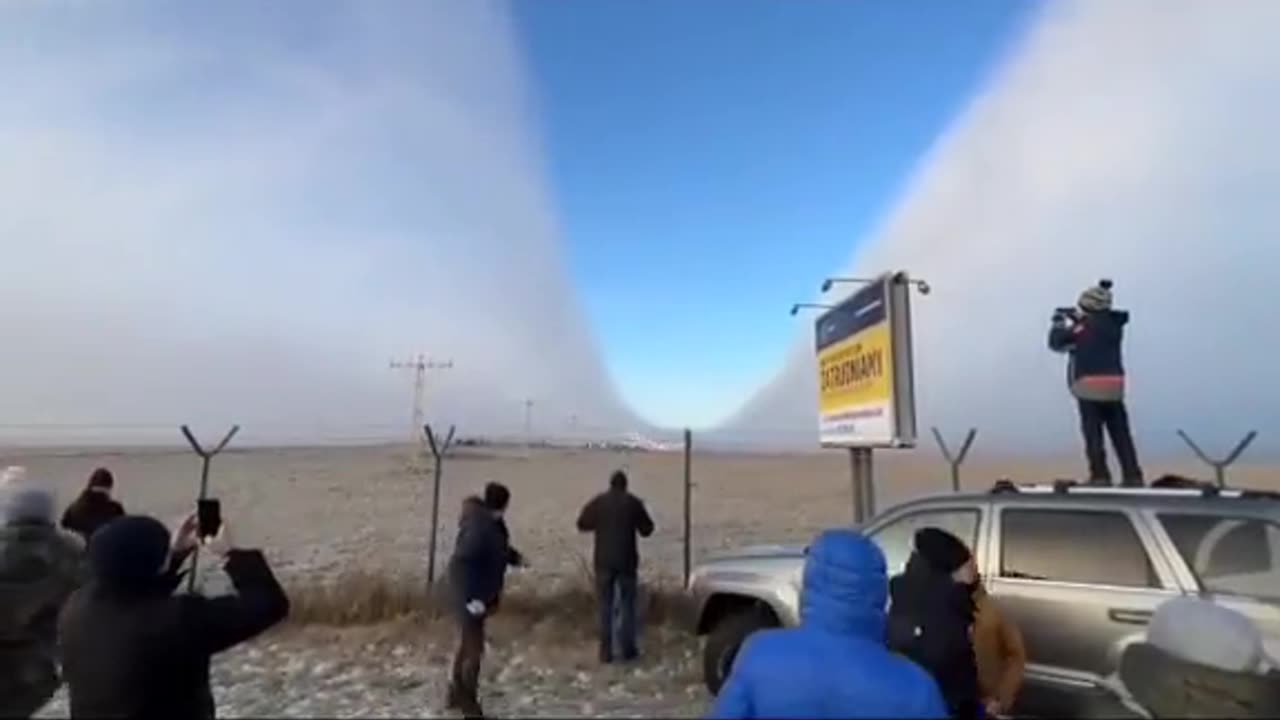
[724,0,1280,451]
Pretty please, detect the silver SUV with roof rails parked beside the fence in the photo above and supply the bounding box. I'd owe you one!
[687,480,1280,717]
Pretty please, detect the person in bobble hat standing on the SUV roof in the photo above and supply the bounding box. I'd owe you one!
[1048,281,1142,487]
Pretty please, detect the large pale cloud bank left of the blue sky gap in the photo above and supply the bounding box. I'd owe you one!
[0,0,634,441]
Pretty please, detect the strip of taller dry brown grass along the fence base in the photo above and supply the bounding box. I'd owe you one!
[288,568,681,637]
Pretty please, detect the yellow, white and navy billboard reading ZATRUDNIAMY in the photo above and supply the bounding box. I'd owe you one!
[814,273,915,447]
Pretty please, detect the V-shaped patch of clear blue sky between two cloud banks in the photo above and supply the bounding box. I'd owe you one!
[513,0,1038,425]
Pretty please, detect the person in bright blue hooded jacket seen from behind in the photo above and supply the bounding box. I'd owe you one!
[709,529,947,720]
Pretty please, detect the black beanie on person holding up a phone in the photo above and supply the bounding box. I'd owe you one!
[88,515,169,589]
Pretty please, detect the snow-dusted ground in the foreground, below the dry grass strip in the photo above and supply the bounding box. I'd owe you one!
[38,621,708,717]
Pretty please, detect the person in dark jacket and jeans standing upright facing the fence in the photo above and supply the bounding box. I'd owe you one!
[577,470,653,662]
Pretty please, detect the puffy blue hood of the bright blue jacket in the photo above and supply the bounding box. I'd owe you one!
[800,529,888,642]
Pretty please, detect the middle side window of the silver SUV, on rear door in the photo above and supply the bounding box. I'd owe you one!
[1000,510,1160,588]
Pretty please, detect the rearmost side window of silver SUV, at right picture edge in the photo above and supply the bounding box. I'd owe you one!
[1158,512,1280,600]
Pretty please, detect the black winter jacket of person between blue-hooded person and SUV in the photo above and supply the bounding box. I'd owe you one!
[887,553,980,717]
